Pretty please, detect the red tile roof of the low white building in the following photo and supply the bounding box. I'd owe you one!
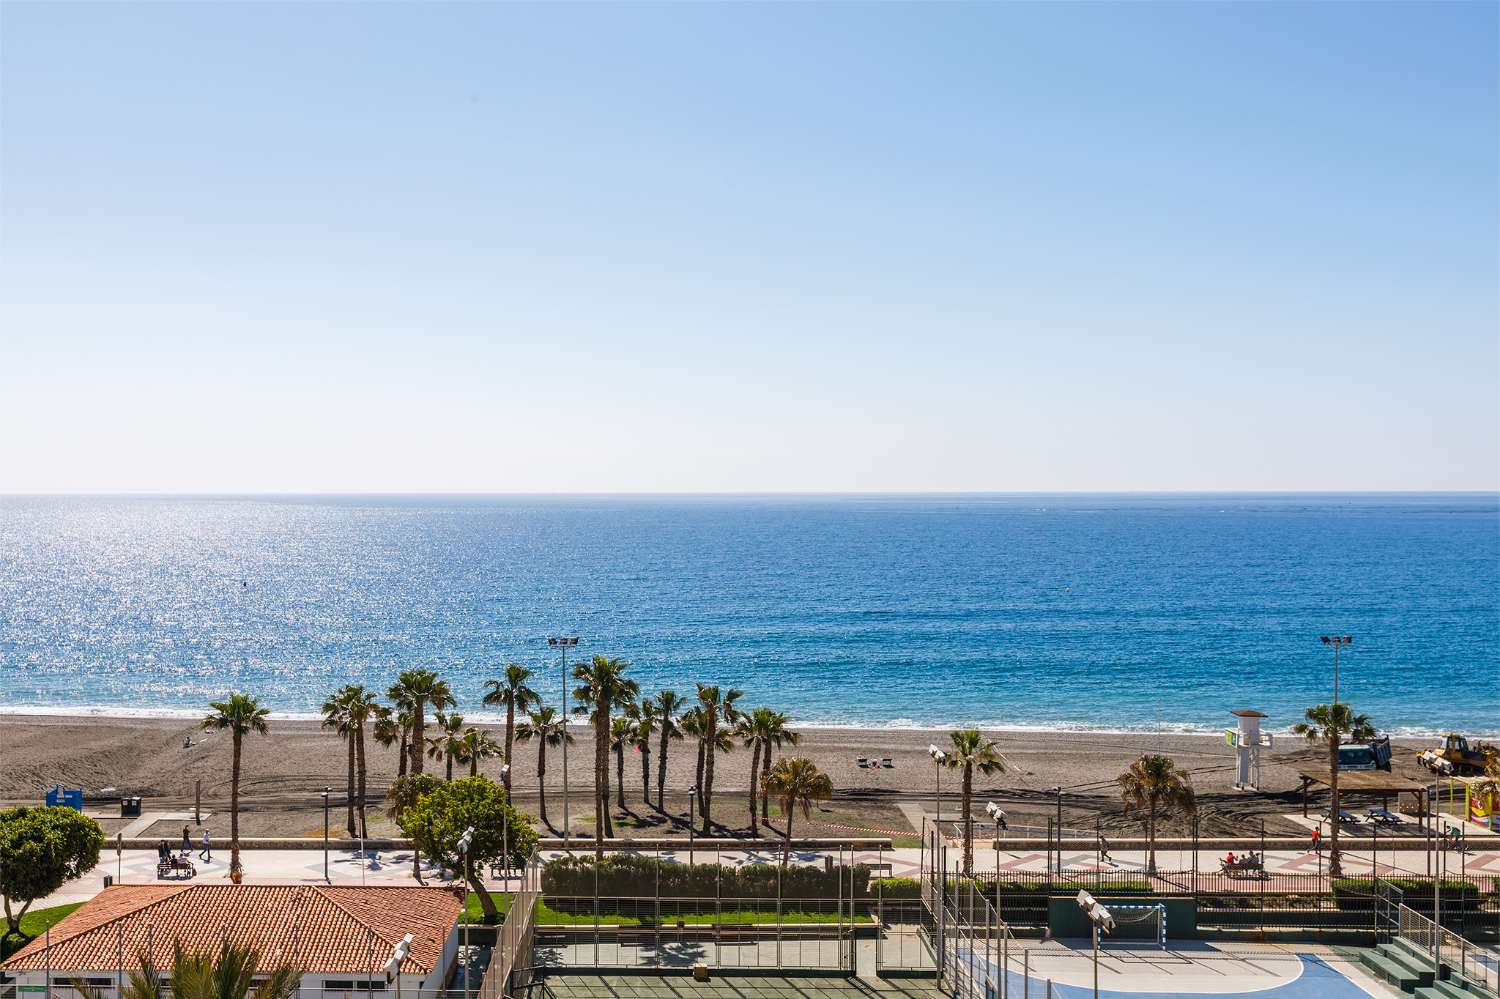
[0,884,464,975]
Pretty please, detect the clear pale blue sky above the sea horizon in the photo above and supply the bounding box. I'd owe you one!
[0,3,1500,492]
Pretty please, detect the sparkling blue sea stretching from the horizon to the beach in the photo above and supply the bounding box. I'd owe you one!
[0,494,1500,735]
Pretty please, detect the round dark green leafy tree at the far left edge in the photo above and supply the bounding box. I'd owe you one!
[0,806,104,933]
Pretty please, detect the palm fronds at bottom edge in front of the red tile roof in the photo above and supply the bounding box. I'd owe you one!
[114,941,302,999]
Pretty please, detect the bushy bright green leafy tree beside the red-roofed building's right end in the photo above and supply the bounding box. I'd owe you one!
[401,777,537,923]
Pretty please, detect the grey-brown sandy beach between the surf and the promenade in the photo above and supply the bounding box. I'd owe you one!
[0,716,1424,836]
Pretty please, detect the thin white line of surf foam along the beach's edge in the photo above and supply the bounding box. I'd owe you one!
[0,704,1500,741]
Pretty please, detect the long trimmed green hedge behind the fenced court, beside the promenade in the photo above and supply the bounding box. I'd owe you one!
[542,854,870,900]
